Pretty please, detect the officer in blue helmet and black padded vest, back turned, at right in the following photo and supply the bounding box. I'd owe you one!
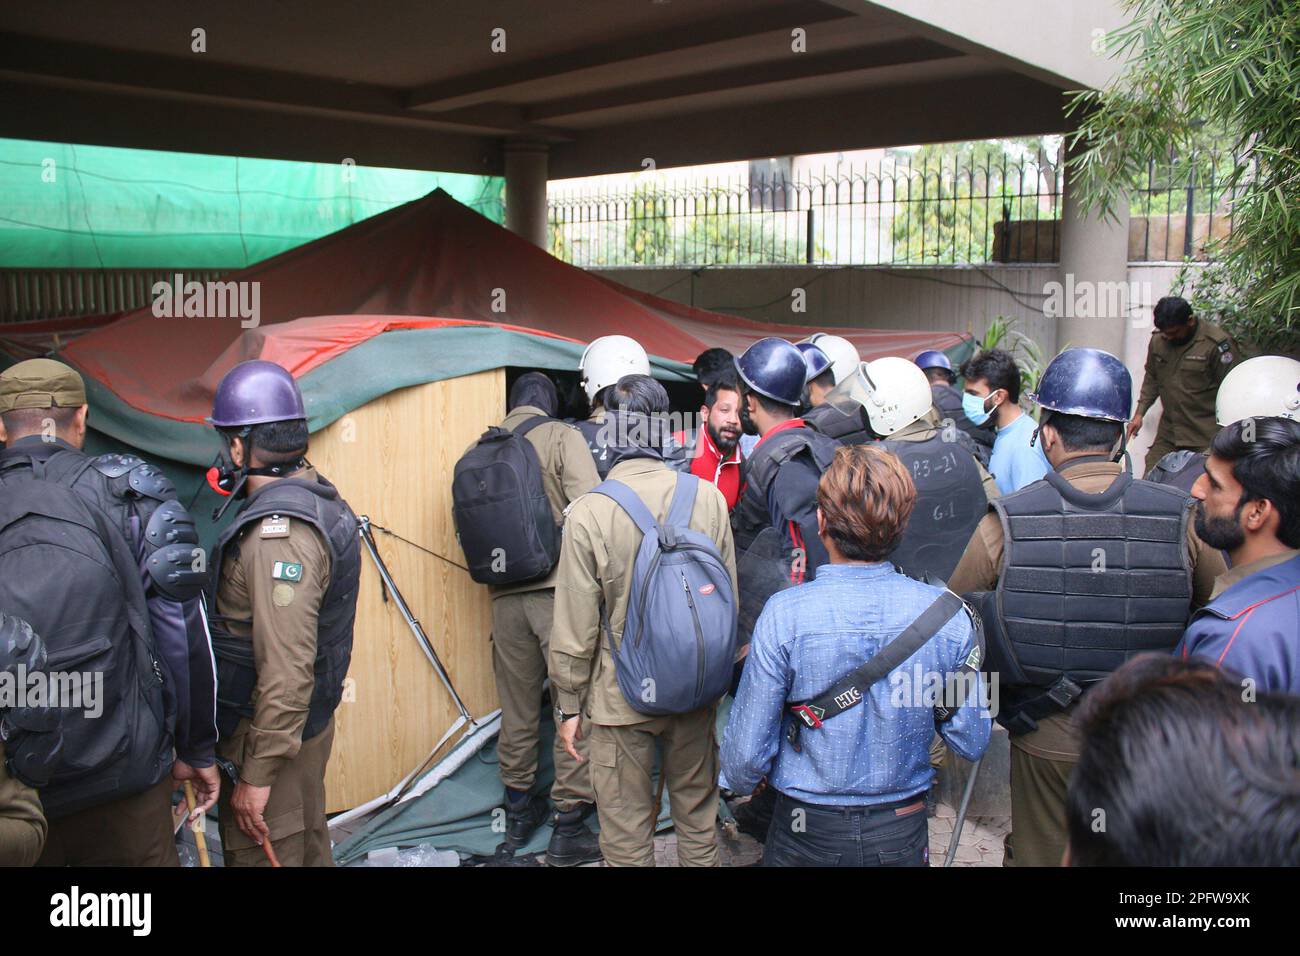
[949,349,1223,866]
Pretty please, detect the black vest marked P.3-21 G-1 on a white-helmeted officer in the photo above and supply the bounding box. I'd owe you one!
[880,429,988,581]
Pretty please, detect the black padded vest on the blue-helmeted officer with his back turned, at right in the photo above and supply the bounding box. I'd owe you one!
[989,471,1192,700]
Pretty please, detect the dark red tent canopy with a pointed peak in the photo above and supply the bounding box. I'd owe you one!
[10,190,965,421]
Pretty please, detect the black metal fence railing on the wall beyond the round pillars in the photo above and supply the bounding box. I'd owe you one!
[547,151,1232,268]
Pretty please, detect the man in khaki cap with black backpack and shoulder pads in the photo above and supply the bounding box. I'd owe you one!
[0,359,220,866]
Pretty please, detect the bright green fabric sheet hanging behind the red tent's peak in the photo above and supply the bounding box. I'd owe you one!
[0,139,504,269]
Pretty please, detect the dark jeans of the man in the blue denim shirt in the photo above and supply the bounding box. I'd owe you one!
[763,793,930,866]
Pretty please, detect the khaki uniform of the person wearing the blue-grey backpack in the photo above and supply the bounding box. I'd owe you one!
[550,458,736,866]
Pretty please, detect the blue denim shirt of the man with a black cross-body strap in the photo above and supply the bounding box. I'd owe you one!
[722,562,993,805]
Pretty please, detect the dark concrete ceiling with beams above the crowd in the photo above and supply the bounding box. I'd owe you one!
[0,0,1091,178]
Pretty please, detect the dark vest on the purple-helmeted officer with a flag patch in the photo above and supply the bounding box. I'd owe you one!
[208,479,361,740]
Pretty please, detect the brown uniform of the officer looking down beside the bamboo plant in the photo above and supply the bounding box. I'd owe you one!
[1138,320,1242,470]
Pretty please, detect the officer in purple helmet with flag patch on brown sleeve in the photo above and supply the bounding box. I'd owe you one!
[208,360,361,866]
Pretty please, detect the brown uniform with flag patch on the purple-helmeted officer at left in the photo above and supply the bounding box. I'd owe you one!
[216,468,334,866]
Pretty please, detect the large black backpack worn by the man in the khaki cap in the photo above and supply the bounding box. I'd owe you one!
[0,459,173,819]
